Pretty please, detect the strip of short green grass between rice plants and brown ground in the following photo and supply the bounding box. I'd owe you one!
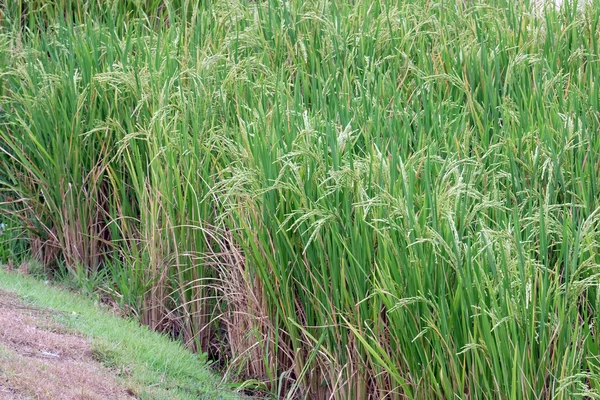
[0,269,239,400]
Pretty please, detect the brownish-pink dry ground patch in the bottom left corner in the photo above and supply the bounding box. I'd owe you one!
[0,290,135,400]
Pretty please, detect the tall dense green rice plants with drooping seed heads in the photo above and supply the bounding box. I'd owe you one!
[0,0,600,399]
